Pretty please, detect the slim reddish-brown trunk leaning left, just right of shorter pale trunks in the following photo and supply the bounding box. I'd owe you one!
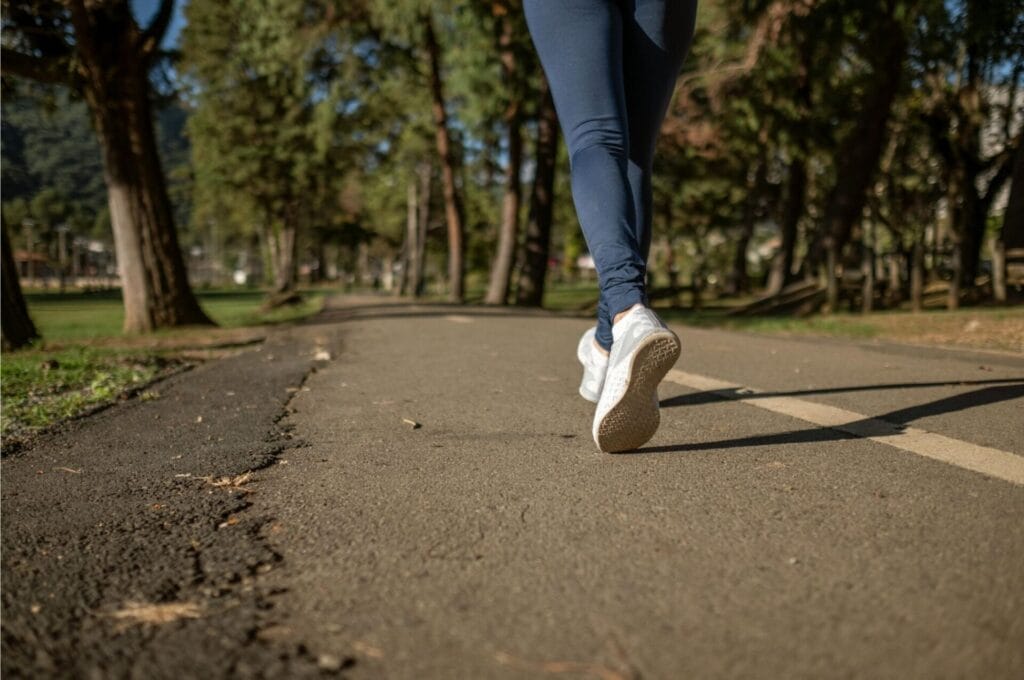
[421,11,466,302]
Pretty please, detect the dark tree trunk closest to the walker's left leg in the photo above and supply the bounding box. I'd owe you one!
[516,80,558,307]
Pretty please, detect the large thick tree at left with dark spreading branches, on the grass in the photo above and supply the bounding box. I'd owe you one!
[0,0,212,332]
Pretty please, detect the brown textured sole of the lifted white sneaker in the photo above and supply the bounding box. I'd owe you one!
[595,332,680,454]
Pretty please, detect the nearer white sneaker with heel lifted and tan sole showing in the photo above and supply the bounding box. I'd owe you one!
[593,305,680,453]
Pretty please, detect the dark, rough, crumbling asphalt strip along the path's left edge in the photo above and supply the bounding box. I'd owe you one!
[0,331,351,678]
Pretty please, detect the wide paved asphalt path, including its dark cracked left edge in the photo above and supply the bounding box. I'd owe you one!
[3,298,1024,679]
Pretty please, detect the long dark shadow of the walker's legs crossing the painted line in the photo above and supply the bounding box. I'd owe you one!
[629,378,1024,454]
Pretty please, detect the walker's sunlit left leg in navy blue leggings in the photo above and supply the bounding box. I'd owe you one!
[523,0,646,349]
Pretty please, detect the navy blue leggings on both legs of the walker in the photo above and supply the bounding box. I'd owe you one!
[523,0,696,349]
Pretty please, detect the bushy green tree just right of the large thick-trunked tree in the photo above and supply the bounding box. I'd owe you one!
[182,0,376,305]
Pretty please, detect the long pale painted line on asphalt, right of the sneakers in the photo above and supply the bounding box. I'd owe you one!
[665,369,1024,485]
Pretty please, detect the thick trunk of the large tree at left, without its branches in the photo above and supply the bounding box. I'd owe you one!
[72,3,213,332]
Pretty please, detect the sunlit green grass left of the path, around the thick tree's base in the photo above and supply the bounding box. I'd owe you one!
[0,289,333,451]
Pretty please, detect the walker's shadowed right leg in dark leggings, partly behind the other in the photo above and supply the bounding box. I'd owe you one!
[623,0,697,262]
